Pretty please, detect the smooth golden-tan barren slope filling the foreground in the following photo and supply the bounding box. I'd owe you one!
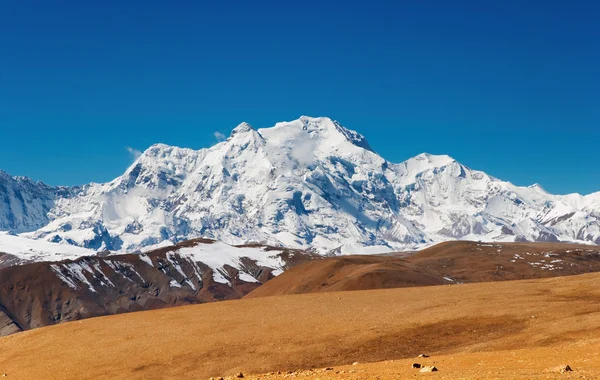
[0,274,600,379]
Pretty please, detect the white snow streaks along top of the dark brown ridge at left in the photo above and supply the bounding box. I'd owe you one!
[44,239,314,293]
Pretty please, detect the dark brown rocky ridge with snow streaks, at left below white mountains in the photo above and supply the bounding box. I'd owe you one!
[0,239,317,336]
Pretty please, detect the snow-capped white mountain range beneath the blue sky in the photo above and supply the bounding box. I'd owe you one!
[0,116,600,253]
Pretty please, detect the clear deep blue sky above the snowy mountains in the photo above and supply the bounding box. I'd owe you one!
[0,0,600,193]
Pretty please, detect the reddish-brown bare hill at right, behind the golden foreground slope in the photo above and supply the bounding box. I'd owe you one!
[246,241,600,298]
